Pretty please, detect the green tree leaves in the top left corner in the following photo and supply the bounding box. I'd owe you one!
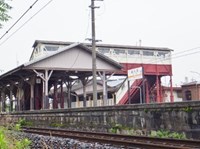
[0,0,12,28]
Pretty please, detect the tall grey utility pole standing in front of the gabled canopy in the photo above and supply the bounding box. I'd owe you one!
[90,0,101,107]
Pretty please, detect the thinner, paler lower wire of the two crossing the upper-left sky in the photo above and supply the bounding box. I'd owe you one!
[0,0,53,46]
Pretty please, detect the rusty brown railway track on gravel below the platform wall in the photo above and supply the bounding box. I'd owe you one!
[23,127,200,149]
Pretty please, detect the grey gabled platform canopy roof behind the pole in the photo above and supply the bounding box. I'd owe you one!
[0,43,122,84]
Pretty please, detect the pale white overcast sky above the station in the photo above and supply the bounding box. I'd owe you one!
[0,0,200,86]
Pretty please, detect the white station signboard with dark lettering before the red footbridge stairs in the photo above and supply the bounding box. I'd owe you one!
[128,67,143,81]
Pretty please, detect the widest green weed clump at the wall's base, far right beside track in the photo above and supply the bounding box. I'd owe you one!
[150,130,186,139]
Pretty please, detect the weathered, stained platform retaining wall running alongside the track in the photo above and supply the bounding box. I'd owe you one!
[0,101,200,139]
